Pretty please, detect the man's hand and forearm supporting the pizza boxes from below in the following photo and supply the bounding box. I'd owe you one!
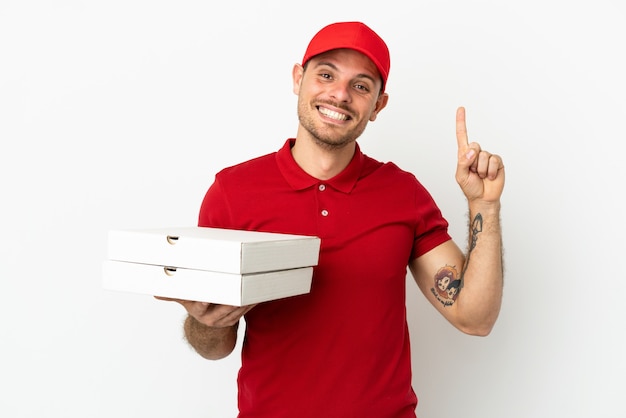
[156,297,255,360]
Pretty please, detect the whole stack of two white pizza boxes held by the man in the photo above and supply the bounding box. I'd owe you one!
[102,227,321,306]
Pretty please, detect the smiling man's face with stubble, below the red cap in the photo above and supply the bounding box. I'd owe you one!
[293,49,387,148]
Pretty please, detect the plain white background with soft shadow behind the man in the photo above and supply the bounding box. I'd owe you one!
[0,0,626,418]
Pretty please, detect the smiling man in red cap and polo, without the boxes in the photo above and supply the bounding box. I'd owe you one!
[156,22,504,418]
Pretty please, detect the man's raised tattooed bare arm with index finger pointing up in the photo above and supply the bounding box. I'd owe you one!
[409,108,504,335]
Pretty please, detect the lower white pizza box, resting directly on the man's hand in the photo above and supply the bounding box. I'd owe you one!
[103,260,313,306]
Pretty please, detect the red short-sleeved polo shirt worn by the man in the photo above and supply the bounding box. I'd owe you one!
[199,139,450,418]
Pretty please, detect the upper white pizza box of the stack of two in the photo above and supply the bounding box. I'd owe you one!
[108,227,320,274]
